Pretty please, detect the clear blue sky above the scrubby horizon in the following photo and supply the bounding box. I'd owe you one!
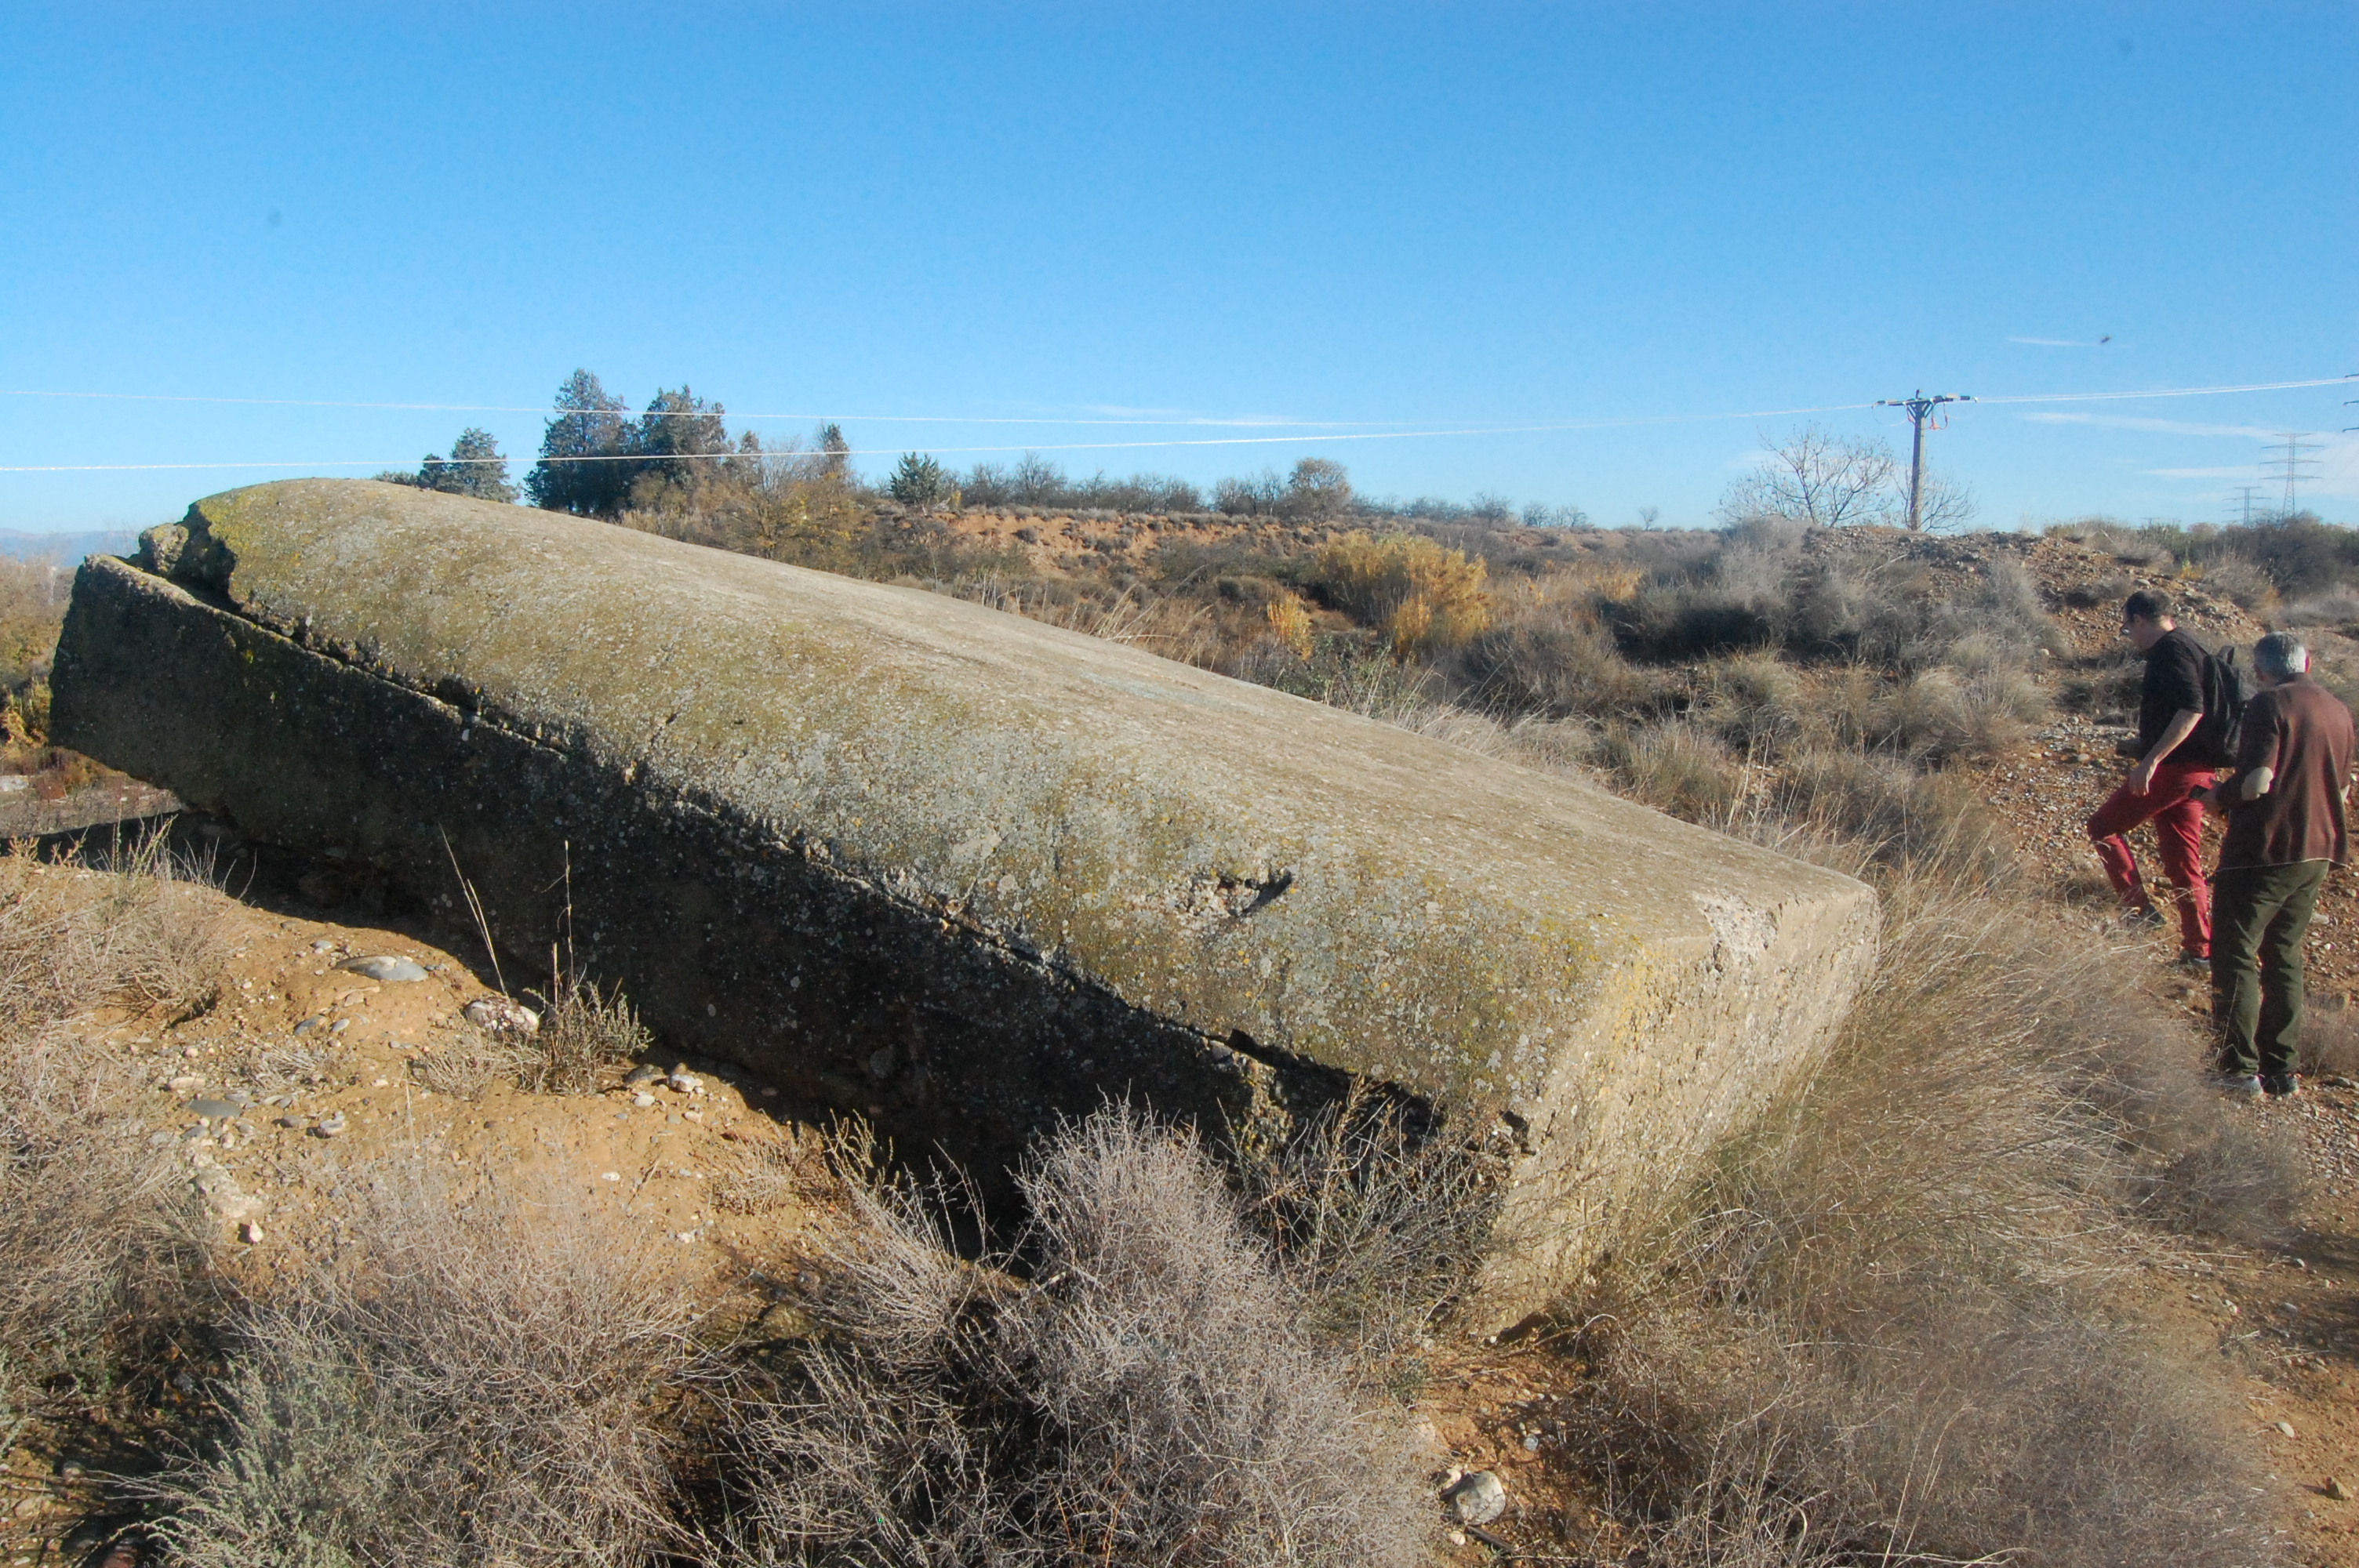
[0,0,2359,528]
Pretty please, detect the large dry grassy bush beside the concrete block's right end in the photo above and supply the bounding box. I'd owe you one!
[1594,880,2286,1566]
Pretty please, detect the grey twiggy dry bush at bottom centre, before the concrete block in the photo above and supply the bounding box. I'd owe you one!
[741,1109,1430,1568]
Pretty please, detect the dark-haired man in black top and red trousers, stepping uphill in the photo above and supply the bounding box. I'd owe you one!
[2088,590,2225,969]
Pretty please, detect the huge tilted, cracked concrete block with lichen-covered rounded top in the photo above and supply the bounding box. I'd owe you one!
[54,481,1873,1313]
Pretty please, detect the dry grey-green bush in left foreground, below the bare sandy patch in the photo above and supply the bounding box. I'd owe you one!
[144,1172,705,1568]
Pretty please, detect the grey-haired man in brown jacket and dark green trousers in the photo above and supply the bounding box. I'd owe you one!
[2210,632,2354,1096]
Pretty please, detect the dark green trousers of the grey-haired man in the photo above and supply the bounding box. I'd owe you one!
[2213,861,2328,1073]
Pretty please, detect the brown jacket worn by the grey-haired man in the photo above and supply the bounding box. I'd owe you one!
[2220,674,2354,870]
